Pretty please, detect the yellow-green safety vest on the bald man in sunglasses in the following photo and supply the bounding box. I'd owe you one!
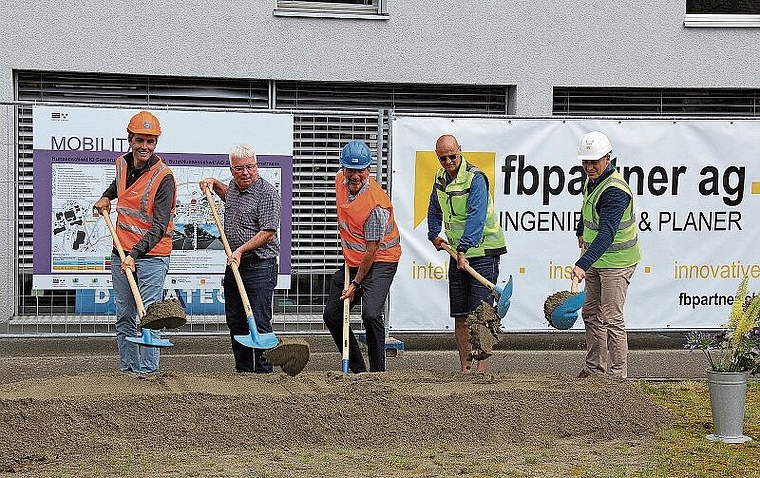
[435,158,507,257]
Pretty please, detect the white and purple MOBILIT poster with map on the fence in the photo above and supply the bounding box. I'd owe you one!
[32,106,293,290]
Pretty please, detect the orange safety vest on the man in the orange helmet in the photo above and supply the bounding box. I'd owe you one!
[116,155,177,256]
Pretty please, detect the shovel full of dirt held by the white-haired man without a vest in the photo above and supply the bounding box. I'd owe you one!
[203,188,310,376]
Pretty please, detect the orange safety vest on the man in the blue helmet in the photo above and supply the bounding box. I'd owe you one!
[335,170,401,267]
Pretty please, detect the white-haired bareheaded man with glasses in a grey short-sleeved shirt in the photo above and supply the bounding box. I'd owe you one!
[199,145,282,373]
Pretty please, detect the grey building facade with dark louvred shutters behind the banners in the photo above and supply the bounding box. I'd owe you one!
[0,0,760,331]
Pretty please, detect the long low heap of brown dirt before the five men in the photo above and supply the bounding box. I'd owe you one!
[0,370,672,478]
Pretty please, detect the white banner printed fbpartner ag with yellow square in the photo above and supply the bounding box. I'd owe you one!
[389,115,760,331]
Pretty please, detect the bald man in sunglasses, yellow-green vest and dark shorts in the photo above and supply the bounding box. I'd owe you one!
[427,134,507,373]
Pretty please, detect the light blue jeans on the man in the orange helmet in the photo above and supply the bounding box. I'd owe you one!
[111,254,169,373]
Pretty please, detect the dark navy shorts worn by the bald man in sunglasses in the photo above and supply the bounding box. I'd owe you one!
[449,256,500,317]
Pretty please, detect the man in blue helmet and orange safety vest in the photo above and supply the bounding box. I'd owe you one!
[323,141,401,373]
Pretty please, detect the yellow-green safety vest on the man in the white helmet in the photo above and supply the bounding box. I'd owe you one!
[582,171,641,269]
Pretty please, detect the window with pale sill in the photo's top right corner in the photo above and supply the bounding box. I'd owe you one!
[683,0,760,28]
